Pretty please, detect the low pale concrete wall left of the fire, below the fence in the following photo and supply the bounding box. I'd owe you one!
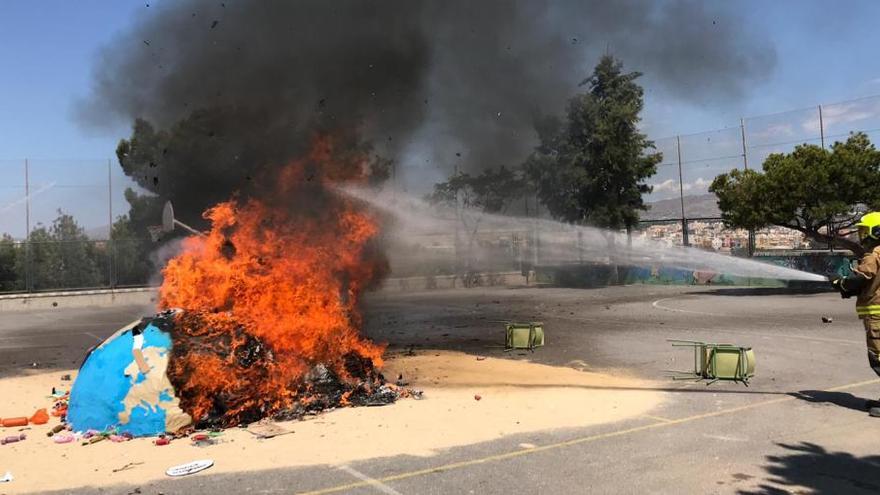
[0,287,156,312]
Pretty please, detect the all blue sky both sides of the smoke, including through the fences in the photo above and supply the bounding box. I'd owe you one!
[0,0,880,234]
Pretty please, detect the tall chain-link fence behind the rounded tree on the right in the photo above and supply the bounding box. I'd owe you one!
[638,96,880,255]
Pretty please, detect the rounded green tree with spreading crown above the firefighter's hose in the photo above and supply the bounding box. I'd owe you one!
[709,133,880,254]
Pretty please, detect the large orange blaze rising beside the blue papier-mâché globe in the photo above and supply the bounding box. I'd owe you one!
[159,138,387,425]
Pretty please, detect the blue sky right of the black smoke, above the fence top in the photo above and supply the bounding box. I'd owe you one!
[646,0,880,137]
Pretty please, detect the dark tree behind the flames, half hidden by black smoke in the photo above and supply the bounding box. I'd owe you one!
[116,114,393,229]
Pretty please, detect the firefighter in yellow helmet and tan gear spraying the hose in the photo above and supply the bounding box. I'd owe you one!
[831,212,880,417]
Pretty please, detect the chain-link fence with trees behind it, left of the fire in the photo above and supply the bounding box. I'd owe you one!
[0,159,152,292]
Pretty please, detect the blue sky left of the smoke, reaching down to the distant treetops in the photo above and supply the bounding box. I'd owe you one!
[0,0,147,237]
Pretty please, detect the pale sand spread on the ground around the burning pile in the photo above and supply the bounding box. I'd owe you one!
[0,351,663,494]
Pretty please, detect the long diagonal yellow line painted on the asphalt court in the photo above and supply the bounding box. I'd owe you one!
[300,378,880,495]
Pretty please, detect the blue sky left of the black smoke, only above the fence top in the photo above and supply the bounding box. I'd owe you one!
[0,0,143,159]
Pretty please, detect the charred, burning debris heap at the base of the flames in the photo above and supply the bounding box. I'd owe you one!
[163,309,404,428]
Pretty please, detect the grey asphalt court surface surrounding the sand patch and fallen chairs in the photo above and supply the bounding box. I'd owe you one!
[6,286,880,494]
